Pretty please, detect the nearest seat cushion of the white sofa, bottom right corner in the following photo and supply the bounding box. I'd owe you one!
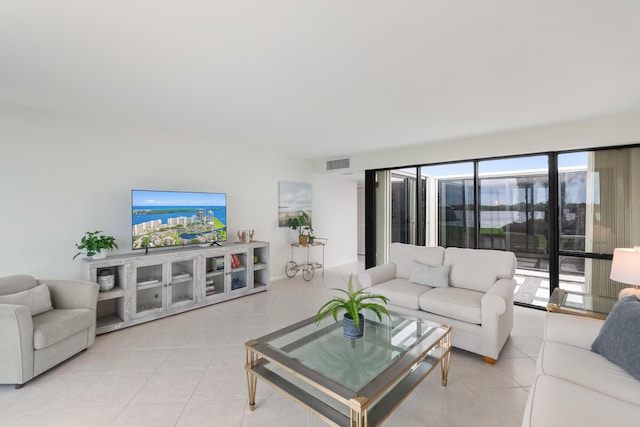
[522,375,640,427]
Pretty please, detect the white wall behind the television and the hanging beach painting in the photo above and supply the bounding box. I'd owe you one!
[0,105,357,278]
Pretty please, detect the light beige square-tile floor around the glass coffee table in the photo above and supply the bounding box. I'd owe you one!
[0,264,544,427]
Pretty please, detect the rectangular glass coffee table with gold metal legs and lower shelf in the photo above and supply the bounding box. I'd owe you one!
[245,313,451,427]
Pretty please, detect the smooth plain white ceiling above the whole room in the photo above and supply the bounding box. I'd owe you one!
[0,0,640,159]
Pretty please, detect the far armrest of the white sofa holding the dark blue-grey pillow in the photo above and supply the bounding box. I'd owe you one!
[544,313,604,350]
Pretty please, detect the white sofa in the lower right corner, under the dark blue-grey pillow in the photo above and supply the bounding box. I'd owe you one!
[522,313,640,427]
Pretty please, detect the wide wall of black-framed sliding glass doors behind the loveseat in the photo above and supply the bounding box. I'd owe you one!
[367,147,640,307]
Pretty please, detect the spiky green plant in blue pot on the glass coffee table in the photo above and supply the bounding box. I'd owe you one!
[316,275,391,338]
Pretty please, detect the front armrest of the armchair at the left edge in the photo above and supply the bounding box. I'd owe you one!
[0,304,33,384]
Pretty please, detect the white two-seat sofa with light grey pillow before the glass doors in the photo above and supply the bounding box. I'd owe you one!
[358,243,516,363]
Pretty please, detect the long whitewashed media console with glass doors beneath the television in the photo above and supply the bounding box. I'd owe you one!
[83,242,269,334]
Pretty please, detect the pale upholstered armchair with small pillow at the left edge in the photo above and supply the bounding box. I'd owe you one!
[0,275,99,388]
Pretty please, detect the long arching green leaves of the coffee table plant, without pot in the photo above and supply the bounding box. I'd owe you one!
[316,275,391,330]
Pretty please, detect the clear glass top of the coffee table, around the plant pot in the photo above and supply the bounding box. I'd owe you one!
[259,312,440,390]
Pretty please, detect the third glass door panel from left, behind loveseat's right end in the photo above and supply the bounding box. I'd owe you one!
[477,155,550,305]
